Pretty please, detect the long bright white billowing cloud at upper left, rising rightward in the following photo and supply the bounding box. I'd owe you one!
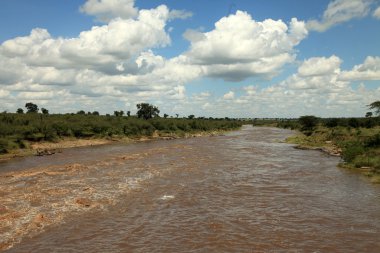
[0,5,170,71]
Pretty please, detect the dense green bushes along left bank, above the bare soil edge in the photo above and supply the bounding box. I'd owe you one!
[0,111,242,153]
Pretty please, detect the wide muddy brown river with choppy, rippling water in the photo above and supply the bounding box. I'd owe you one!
[0,126,380,252]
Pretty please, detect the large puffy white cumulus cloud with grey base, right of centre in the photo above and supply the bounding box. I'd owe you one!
[184,11,308,81]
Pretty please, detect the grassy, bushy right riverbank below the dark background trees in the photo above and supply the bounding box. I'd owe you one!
[286,126,380,183]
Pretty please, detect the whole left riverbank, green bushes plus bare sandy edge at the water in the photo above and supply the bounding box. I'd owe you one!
[0,112,245,159]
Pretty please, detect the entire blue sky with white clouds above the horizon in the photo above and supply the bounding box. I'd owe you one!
[0,0,380,118]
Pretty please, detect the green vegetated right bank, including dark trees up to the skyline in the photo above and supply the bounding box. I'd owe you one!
[278,116,380,183]
